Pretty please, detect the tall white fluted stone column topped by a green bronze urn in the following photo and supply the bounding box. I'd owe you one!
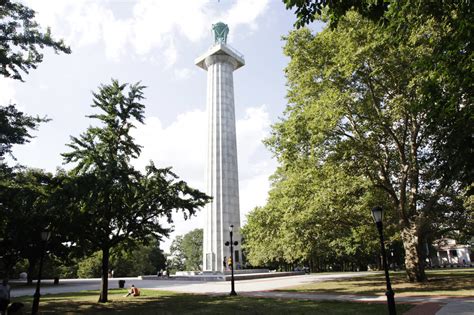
[195,22,245,272]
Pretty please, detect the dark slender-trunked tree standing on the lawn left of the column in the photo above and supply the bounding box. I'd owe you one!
[63,80,209,302]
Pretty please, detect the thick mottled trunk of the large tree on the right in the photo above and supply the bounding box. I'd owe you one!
[402,223,426,282]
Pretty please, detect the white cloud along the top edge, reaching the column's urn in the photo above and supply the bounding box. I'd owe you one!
[25,0,269,66]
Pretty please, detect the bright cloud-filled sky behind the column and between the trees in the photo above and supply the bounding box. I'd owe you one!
[0,0,320,252]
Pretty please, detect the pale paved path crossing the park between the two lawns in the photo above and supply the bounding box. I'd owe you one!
[12,272,474,315]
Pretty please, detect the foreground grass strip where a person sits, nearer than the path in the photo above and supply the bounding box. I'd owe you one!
[10,289,413,315]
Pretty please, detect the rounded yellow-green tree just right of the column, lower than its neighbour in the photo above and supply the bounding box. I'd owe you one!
[242,161,384,271]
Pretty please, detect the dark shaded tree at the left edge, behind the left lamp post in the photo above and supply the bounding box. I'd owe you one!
[0,168,66,282]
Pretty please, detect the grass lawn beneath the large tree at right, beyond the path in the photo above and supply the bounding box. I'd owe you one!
[280,268,474,297]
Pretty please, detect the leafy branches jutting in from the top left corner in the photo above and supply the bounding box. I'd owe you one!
[0,0,71,81]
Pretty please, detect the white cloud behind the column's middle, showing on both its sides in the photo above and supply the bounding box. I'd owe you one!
[133,106,275,249]
